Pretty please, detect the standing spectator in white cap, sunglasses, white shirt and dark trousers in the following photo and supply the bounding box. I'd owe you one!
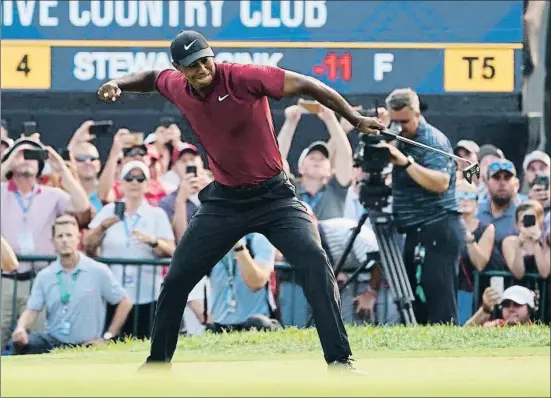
[85,160,175,338]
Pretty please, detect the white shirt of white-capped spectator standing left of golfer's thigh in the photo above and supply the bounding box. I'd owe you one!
[89,200,175,304]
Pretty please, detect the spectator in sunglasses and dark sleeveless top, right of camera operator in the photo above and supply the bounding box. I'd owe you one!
[455,179,495,325]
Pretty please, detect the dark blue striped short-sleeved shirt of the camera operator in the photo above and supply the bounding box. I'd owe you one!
[392,117,458,228]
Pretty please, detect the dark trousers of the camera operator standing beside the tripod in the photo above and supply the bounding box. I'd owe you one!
[404,214,465,325]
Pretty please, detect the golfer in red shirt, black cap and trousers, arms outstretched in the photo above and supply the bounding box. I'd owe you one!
[98,31,385,371]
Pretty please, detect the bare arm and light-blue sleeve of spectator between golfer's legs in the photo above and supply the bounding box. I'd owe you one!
[235,235,275,291]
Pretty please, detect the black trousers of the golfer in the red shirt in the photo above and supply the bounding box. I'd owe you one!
[147,173,351,362]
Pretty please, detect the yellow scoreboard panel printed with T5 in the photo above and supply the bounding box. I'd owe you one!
[444,48,515,92]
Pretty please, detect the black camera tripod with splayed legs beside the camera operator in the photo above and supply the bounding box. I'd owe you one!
[307,181,417,327]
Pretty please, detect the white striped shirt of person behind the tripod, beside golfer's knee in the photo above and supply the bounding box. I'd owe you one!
[319,218,379,271]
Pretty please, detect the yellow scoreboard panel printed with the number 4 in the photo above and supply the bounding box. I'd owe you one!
[0,40,52,90]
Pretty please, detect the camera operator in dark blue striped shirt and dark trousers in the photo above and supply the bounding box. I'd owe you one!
[379,88,465,324]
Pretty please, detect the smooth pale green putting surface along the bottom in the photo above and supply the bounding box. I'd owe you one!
[1,347,550,397]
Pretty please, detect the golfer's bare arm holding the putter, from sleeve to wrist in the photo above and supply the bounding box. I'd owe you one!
[283,71,362,126]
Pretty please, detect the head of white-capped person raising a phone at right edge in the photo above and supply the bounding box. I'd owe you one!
[523,151,551,214]
